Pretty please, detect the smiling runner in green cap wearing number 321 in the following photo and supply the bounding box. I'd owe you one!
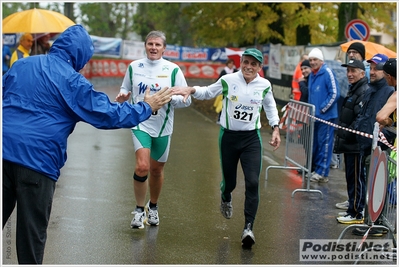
[172,48,281,247]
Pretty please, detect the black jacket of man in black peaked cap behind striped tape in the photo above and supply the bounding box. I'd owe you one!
[334,77,368,154]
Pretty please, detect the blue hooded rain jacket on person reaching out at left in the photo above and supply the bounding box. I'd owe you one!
[2,25,152,181]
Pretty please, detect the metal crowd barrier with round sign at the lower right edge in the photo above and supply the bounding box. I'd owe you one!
[337,123,397,264]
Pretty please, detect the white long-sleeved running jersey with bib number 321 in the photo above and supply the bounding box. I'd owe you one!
[192,71,280,131]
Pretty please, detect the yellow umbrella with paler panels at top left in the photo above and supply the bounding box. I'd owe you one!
[2,8,75,33]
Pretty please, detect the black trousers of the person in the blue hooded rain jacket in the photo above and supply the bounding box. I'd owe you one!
[3,160,55,264]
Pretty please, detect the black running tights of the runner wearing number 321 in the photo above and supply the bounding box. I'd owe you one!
[219,128,262,229]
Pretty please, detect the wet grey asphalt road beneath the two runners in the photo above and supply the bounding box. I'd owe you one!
[2,87,396,265]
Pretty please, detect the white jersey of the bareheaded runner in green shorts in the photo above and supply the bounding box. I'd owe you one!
[120,58,191,137]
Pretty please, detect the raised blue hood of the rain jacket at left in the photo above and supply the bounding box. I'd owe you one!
[49,25,94,71]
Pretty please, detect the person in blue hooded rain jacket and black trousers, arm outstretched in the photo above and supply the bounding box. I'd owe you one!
[2,25,171,264]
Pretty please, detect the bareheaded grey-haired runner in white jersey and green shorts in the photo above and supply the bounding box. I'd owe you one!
[115,31,191,229]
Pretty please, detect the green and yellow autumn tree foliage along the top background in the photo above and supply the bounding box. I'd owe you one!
[2,1,397,51]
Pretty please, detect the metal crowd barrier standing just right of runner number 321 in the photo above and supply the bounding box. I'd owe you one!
[266,100,323,198]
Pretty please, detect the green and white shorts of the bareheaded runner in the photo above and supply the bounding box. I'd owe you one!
[132,130,171,162]
